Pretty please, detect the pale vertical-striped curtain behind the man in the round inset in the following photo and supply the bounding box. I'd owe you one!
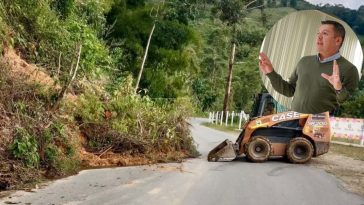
[260,10,363,109]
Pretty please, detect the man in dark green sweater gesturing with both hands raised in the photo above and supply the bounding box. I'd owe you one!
[259,21,359,114]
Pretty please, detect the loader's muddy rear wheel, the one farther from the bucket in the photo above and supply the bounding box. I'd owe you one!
[286,137,314,164]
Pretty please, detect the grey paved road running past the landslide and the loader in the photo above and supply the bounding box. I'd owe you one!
[0,119,364,205]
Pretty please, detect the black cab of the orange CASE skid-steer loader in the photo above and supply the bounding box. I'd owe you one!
[251,93,288,118]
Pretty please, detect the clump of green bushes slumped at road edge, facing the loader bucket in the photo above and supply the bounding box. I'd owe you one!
[69,77,196,156]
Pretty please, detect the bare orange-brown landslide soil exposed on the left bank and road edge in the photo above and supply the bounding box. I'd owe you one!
[0,48,192,195]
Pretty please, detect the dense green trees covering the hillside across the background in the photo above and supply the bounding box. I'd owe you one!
[0,0,364,115]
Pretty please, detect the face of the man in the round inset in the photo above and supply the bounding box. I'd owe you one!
[316,24,342,55]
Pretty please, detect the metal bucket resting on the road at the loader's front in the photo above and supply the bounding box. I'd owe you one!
[207,139,236,162]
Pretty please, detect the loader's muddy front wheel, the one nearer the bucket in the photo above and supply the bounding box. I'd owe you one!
[245,137,271,162]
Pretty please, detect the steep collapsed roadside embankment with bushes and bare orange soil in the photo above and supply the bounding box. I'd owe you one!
[0,48,196,191]
